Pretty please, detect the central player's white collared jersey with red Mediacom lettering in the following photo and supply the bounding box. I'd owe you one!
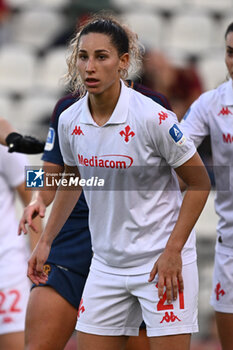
[58,83,196,274]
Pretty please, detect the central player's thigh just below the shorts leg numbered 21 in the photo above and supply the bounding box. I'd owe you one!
[149,334,191,350]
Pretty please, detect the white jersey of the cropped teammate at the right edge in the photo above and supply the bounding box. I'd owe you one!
[181,80,233,254]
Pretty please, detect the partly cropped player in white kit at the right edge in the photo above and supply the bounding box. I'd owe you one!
[182,23,233,350]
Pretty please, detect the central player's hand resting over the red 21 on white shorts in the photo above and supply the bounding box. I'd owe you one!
[149,249,184,304]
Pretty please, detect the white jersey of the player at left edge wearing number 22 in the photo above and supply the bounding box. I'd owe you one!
[0,145,28,290]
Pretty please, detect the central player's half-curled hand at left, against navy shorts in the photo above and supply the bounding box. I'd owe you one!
[27,240,51,285]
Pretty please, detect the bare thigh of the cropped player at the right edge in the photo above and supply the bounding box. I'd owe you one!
[215,312,233,350]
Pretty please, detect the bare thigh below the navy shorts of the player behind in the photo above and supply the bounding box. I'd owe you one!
[25,286,77,350]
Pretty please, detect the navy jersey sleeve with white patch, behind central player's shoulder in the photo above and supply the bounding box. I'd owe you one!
[42,95,77,166]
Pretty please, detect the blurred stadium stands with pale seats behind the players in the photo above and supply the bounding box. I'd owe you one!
[0,0,233,349]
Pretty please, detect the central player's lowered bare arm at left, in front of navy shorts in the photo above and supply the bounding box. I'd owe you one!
[24,165,82,285]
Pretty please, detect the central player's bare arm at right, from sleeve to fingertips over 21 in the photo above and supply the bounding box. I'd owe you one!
[149,153,210,303]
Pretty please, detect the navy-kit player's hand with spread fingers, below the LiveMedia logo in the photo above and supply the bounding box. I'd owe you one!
[18,199,46,235]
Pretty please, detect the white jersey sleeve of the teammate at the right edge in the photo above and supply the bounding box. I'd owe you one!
[181,93,210,147]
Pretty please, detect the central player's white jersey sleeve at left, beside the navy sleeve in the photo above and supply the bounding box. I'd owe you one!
[58,112,76,166]
